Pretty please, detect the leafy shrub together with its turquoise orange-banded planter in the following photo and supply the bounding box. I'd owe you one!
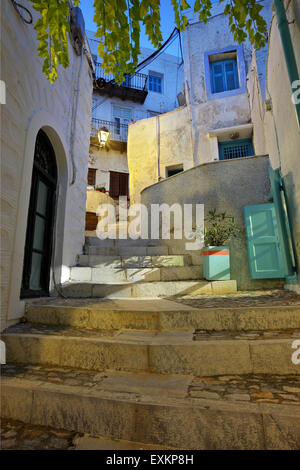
[203,209,242,281]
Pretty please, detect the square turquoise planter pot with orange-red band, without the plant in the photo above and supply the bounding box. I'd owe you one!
[203,246,230,281]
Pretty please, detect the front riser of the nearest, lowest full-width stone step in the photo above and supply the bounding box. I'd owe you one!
[1,381,300,450]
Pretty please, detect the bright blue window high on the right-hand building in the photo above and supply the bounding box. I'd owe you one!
[210,59,239,93]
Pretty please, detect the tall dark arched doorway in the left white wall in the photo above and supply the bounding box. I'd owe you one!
[21,130,57,298]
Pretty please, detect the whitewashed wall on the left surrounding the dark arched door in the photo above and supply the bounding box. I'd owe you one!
[0,1,92,329]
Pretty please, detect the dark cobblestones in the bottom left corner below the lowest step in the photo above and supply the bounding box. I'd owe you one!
[0,419,82,450]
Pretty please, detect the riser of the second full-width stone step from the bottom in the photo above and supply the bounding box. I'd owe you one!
[4,334,299,376]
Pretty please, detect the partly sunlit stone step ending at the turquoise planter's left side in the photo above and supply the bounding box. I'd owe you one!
[70,265,202,284]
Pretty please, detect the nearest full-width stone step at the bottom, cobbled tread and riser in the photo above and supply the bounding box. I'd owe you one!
[1,365,300,450]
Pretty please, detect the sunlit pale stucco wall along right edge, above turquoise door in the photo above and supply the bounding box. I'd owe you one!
[265,0,300,282]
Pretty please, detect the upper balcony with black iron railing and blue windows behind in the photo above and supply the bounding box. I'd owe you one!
[94,62,148,104]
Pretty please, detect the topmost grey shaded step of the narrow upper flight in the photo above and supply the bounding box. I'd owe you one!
[85,245,169,257]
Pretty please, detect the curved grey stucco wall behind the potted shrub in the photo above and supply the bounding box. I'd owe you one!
[142,156,283,290]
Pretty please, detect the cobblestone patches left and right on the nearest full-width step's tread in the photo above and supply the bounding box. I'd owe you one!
[1,364,300,405]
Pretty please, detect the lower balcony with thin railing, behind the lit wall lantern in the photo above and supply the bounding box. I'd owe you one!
[91,118,128,152]
